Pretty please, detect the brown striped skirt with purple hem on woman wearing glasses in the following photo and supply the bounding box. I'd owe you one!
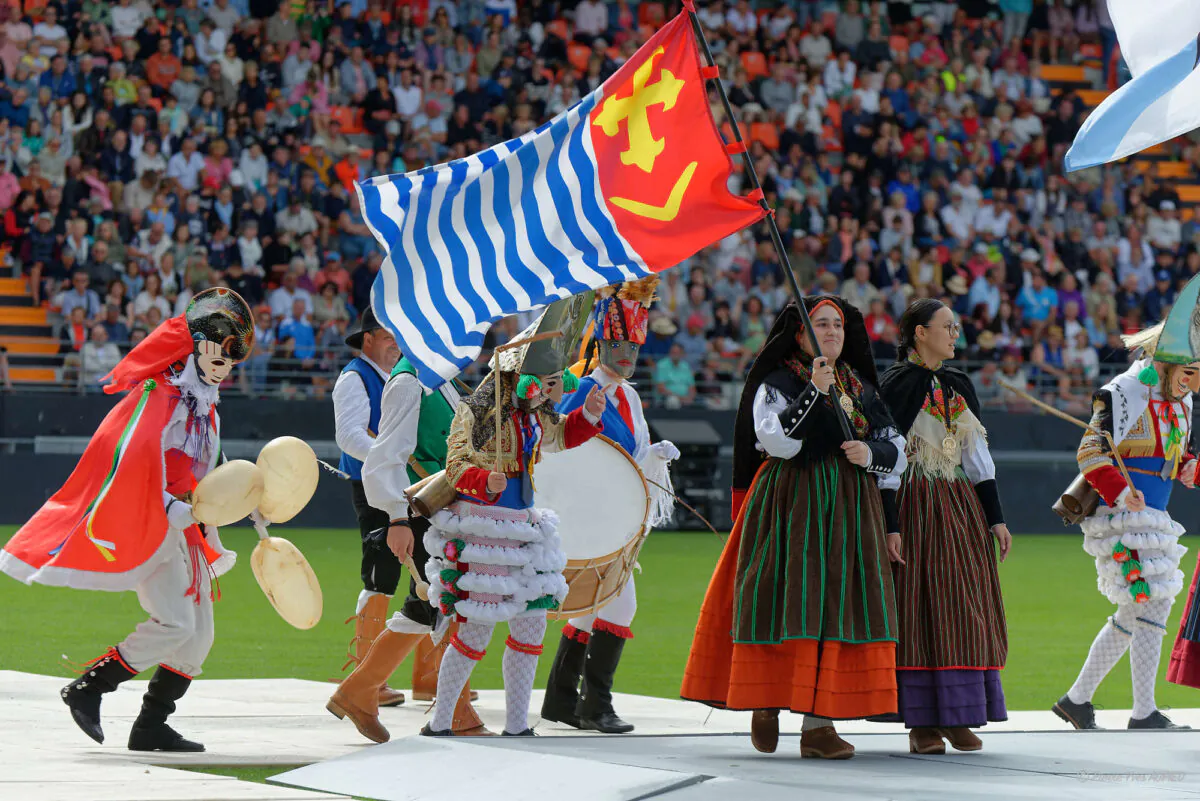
[886,464,1008,727]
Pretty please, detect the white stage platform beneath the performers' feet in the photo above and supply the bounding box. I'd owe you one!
[0,670,1200,801]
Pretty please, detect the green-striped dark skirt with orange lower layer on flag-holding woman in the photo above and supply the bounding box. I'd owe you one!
[682,453,896,719]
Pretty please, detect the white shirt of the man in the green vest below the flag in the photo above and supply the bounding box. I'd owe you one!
[357,373,461,520]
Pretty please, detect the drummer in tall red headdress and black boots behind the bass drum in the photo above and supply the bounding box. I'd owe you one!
[541,276,679,734]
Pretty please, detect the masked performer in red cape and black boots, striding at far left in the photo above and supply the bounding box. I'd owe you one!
[0,289,254,751]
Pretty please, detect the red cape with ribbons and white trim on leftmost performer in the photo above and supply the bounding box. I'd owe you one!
[0,377,225,591]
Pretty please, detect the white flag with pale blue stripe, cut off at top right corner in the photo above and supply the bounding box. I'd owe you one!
[1064,0,1200,173]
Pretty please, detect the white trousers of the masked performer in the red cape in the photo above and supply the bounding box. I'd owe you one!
[118,529,214,676]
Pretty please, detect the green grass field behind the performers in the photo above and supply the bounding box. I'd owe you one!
[0,526,1200,710]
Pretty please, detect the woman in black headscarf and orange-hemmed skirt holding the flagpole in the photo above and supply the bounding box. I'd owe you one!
[682,297,906,759]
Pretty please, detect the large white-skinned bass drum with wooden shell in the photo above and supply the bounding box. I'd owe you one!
[534,435,650,620]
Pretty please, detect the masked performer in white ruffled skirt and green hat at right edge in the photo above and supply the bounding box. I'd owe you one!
[1054,284,1200,729]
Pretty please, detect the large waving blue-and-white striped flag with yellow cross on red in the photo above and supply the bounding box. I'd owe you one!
[356,14,764,389]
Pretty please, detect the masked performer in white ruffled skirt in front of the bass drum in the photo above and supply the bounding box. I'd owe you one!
[421,335,605,736]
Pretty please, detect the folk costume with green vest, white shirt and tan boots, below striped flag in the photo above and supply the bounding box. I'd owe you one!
[326,359,486,742]
